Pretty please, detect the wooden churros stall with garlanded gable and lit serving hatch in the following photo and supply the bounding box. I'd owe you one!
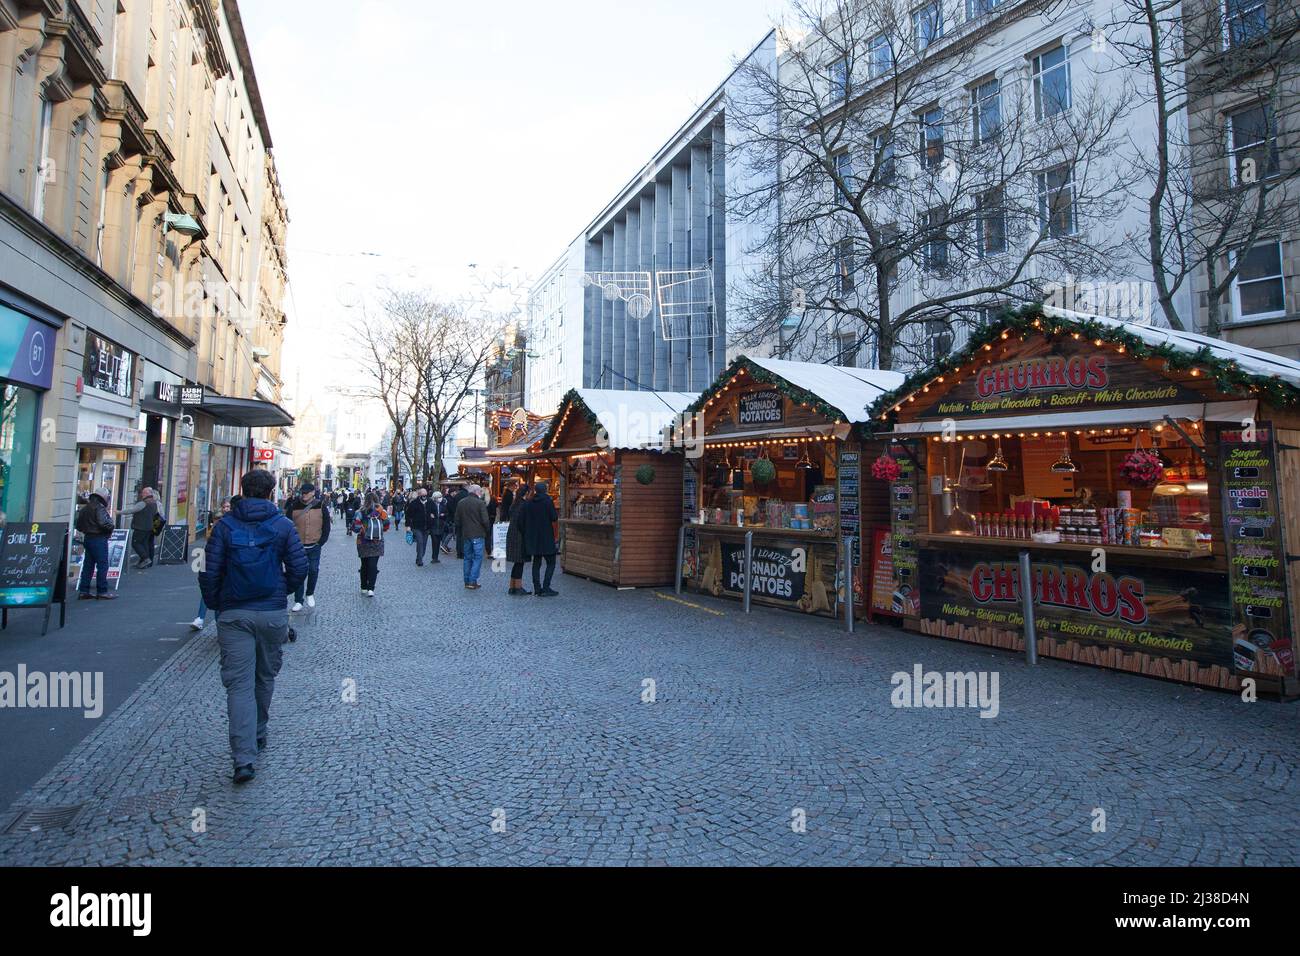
[872,310,1300,696]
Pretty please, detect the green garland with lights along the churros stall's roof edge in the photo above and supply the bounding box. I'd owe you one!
[863,306,1300,437]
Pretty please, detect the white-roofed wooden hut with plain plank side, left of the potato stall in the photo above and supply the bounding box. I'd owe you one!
[542,389,696,588]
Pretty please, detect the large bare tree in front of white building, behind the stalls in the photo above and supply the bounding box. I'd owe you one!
[728,0,1144,368]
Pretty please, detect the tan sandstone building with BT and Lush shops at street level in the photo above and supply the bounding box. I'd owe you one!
[0,0,289,548]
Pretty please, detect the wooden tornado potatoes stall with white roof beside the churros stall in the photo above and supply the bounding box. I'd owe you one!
[681,356,902,617]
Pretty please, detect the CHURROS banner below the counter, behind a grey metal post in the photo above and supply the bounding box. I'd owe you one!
[920,549,1232,667]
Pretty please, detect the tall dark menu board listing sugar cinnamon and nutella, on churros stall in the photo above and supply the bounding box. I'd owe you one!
[1219,424,1296,676]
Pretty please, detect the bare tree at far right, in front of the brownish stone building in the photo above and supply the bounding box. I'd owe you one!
[1105,0,1300,336]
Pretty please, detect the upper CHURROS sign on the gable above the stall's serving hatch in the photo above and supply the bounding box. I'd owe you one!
[920,341,1199,419]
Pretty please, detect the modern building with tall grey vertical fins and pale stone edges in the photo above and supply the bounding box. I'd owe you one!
[528,33,776,411]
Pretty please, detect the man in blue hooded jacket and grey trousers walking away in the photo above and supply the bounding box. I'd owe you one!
[199,471,307,783]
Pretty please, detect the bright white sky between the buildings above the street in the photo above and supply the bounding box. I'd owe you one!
[241,0,783,421]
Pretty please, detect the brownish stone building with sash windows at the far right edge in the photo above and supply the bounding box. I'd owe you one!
[1183,0,1300,358]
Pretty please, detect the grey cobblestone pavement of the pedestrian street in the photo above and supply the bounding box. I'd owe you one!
[0,536,1300,865]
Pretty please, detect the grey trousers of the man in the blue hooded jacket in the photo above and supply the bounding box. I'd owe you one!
[217,610,289,767]
